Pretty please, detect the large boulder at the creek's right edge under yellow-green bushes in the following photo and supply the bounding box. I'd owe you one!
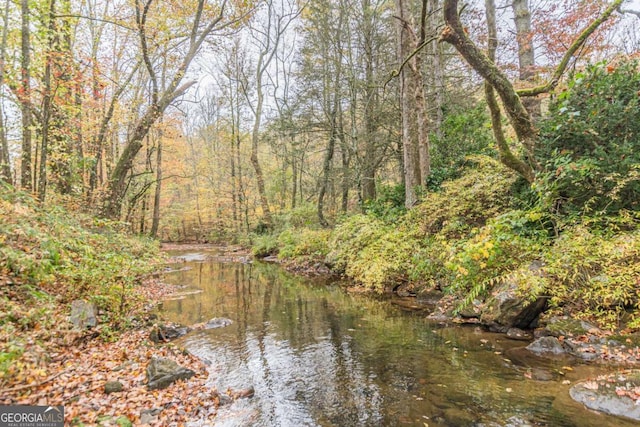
[480,262,547,332]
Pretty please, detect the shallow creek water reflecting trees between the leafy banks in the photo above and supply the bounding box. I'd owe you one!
[160,252,638,427]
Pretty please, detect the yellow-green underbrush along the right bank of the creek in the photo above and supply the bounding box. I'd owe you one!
[254,156,640,329]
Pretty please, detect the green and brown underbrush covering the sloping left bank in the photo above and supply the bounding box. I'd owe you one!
[0,185,161,377]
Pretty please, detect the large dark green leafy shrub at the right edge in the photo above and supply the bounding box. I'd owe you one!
[539,62,640,215]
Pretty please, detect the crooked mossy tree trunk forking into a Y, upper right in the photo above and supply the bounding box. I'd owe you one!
[441,0,623,183]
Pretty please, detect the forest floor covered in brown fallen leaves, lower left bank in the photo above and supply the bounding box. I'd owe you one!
[0,280,229,426]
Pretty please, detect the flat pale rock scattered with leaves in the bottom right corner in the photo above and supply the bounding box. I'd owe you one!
[569,371,640,421]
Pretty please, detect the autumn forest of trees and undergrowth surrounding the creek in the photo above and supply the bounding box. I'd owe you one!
[0,0,640,425]
